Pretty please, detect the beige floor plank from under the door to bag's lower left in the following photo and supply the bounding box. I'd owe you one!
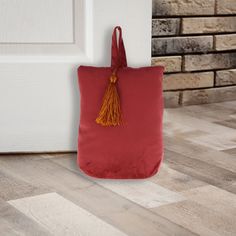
[0,155,93,195]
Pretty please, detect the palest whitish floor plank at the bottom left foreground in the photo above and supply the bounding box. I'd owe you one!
[8,193,126,236]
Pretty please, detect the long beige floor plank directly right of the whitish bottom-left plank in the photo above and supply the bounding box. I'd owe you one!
[60,182,195,236]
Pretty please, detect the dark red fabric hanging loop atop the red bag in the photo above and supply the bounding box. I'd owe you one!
[111,26,127,71]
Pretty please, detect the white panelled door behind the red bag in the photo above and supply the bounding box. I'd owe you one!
[0,0,151,152]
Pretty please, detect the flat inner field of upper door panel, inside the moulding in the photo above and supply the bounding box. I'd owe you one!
[0,0,74,44]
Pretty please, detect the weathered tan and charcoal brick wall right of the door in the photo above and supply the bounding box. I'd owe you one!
[152,0,236,107]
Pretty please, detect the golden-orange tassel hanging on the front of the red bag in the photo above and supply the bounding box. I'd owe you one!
[96,73,121,126]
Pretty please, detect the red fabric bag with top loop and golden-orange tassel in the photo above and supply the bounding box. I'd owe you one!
[77,26,164,179]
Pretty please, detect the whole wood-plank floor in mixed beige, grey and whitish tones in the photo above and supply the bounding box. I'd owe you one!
[0,101,236,236]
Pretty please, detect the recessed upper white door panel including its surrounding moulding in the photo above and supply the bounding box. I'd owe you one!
[0,0,86,55]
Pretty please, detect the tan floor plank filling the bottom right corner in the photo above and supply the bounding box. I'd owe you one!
[153,200,236,236]
